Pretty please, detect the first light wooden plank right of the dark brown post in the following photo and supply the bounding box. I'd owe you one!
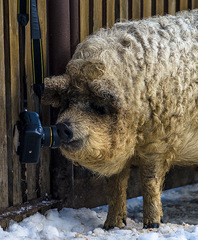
[80,0,89,42]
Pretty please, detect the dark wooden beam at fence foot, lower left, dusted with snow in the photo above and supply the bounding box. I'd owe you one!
[0,198,62,229]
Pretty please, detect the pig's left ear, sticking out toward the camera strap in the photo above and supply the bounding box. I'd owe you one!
[42,74,69,108]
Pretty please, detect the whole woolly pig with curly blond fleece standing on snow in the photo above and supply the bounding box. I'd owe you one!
[43,10,198,229]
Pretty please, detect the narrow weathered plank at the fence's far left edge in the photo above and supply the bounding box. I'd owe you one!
[0,0,8,208]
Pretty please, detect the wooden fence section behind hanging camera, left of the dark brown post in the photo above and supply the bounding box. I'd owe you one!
[0,0,50,211]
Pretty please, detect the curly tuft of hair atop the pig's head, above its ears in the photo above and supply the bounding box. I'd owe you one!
[66,59,105,80]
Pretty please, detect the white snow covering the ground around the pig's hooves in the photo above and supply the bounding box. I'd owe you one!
[0,184,198,240]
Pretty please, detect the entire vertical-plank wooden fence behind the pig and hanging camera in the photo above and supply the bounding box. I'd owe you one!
[0,0,198,225]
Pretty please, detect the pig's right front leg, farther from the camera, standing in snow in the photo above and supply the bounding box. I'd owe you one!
[140,160,169,228]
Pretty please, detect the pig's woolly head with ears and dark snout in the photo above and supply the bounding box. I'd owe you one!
[43,59,136,176]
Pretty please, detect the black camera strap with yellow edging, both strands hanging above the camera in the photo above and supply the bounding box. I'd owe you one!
[17,0,44,117]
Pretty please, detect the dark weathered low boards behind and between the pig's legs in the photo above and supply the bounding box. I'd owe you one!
[63,166,198,208]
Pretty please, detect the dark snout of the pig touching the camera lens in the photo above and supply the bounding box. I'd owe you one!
[56,123,73,143]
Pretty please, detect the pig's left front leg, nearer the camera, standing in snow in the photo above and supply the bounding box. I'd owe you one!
[104,166,130,229]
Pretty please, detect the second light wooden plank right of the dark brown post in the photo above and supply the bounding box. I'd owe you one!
[93,0,102,32]
